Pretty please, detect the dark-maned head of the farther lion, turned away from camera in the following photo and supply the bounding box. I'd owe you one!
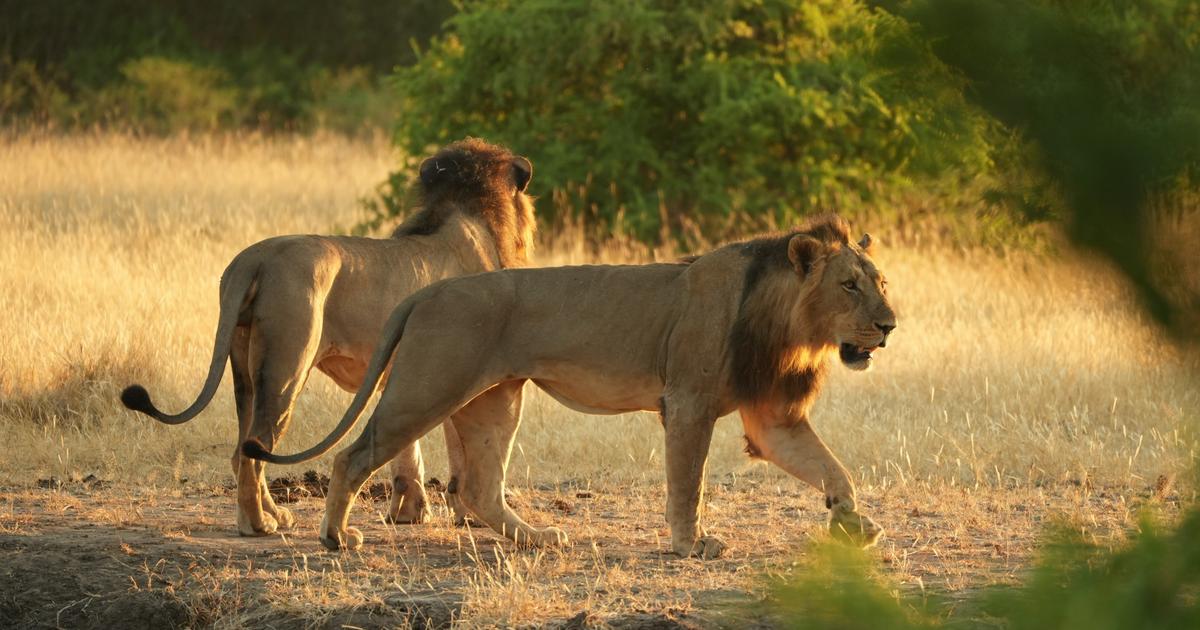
[392,138,538,268]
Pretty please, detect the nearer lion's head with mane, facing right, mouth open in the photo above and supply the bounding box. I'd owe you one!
[730,216,896,401]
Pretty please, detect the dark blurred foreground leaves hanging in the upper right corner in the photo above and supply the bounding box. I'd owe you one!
[902,0,1200,338]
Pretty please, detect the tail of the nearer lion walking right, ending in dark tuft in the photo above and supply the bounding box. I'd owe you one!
[241,296,419,463]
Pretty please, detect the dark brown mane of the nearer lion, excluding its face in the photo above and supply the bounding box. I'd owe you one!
[728,215,851,404]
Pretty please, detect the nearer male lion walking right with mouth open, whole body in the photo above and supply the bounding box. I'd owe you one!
[244,217,895,558]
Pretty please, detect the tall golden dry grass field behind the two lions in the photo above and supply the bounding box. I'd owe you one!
[0,136,1200,486]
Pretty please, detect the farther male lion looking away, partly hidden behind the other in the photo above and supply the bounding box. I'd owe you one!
[121,139,535,536]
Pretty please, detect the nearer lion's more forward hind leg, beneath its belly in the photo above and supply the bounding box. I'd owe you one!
[454,380,568,547]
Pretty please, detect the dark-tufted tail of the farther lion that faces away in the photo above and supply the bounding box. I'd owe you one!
[121,258,258,425]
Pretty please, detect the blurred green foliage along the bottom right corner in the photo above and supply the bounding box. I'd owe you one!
[770,509,1200,630]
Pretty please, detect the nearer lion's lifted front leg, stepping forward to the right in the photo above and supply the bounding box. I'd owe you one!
[742,406,883,547]
